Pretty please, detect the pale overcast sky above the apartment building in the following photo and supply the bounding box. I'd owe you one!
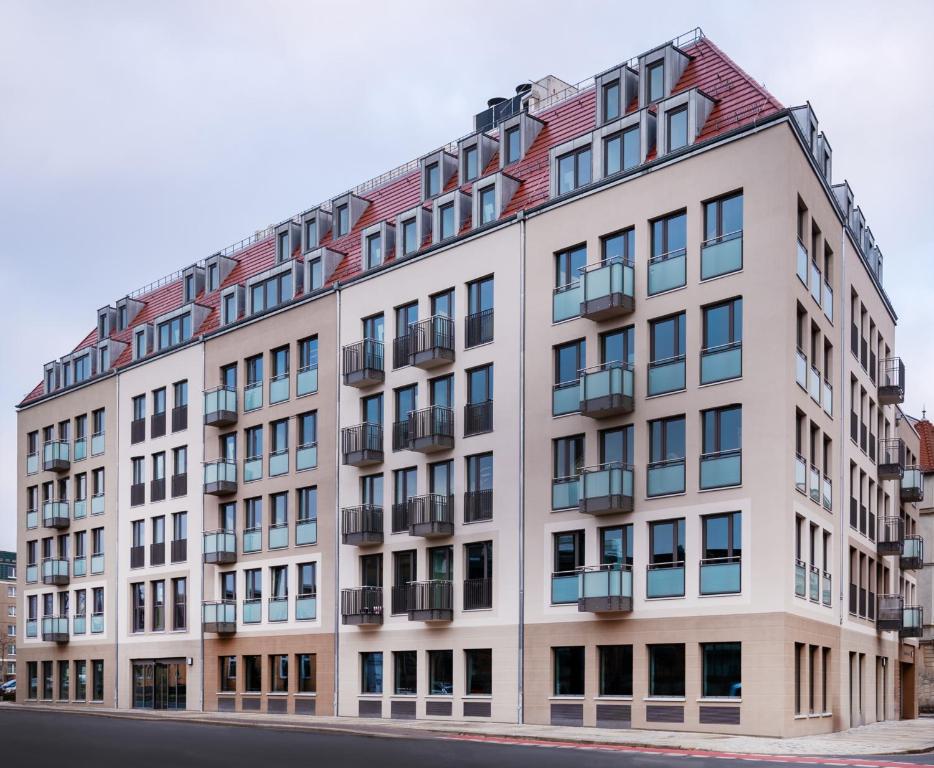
[0,0,934,548]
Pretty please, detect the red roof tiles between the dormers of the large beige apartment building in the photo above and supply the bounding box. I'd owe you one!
[22,38,784,408]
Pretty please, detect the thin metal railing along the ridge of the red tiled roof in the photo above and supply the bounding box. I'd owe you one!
[127,27,708,298]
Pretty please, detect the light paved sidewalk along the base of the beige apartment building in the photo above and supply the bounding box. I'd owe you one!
[0,703,934,756]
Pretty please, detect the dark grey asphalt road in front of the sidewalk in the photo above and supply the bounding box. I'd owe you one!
[0,709,934,768]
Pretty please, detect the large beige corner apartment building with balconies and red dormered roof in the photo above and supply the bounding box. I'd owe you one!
[18,31,934,736]
